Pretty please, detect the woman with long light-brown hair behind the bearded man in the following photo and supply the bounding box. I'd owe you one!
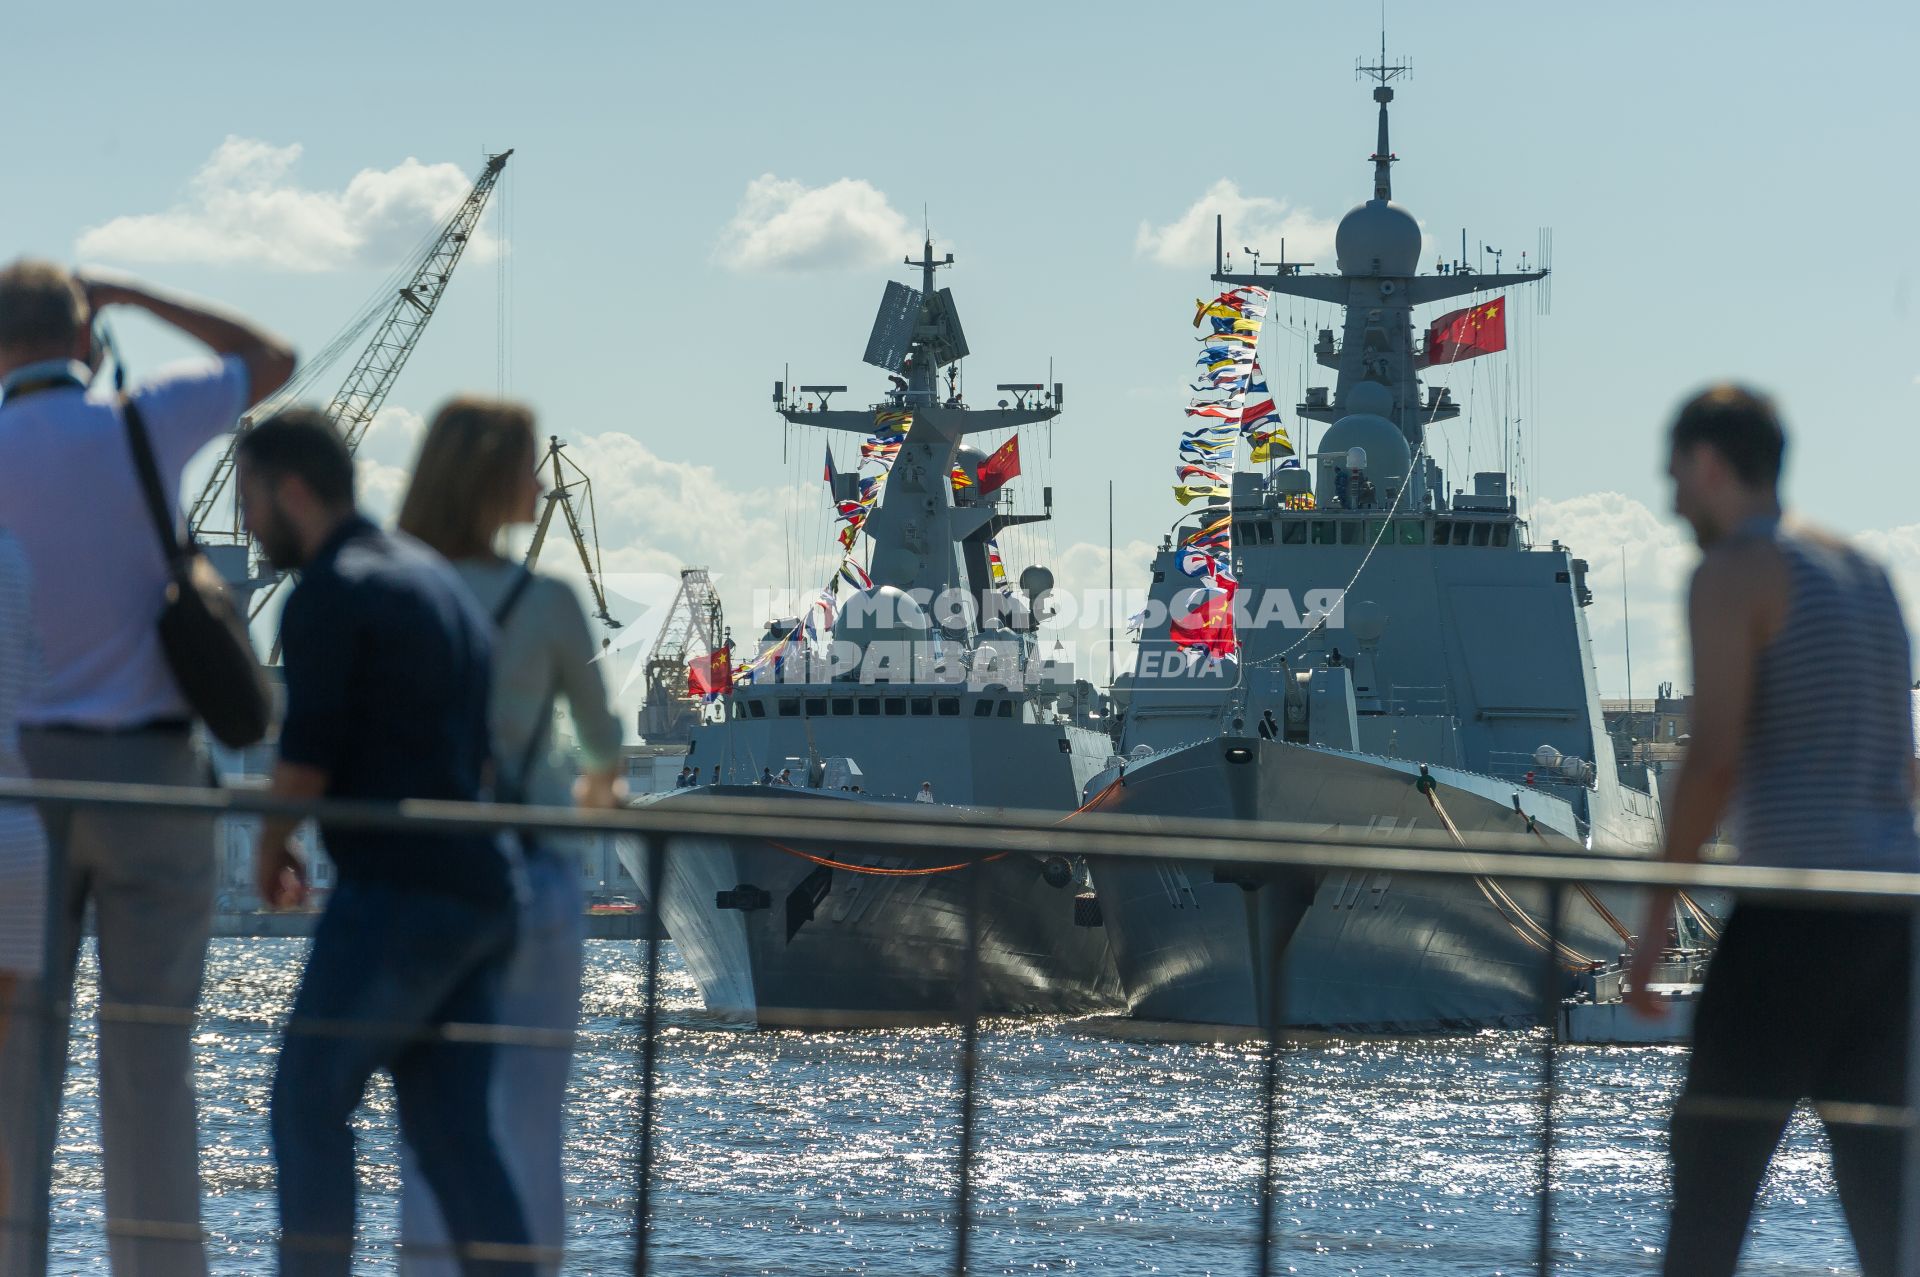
[399,398,620,1277]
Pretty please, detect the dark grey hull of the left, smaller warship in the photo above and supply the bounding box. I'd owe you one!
[622,785,1125,1027]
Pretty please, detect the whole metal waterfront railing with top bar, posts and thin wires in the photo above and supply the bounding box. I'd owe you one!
[0,780,1920,1277]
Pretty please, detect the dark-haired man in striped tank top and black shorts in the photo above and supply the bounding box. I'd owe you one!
[1628,386,1920,1277]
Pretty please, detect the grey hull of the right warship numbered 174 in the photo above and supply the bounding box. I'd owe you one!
[1092,739,1632,1033]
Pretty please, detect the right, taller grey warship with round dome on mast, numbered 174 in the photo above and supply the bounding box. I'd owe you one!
[1089,58,1711,1031]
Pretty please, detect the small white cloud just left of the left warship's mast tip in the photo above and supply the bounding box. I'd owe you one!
[714,173,916,271]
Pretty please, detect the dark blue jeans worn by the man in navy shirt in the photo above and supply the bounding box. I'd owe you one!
[273,881,534,1277]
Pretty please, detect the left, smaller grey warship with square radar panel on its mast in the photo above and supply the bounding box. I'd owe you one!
[622,240,1123,1027]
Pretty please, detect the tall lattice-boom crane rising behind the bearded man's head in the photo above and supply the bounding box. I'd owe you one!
[186,150,514,618]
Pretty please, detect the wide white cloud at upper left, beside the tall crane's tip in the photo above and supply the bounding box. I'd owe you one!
[75,136,497,271]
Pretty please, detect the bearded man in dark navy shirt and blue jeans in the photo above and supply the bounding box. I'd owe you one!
[238,409,534,1277]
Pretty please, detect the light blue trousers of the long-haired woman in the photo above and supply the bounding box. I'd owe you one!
[399,851,586,1277]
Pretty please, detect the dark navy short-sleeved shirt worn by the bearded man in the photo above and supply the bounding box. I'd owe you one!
[280,515,513,899]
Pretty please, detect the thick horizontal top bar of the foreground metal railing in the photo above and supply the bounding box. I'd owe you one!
[0,780,1920,908]
